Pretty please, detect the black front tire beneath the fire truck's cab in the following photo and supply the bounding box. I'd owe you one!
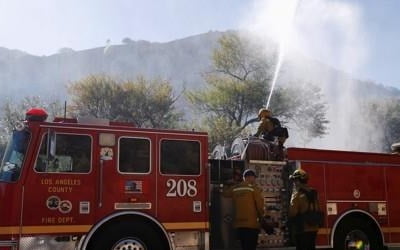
[87,222,169,250]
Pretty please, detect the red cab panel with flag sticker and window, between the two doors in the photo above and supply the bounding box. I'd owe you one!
[96,136,156,219]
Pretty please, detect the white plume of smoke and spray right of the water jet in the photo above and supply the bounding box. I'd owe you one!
[242,0,380,150]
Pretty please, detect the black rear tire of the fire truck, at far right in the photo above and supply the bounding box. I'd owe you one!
[333,218,384,250]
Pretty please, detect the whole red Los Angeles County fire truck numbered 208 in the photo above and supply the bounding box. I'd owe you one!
[0,109,400,250]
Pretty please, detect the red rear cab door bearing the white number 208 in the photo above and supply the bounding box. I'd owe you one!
[157,138,208,230]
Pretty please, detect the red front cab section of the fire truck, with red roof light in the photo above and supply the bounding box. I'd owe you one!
[0,109,209,250]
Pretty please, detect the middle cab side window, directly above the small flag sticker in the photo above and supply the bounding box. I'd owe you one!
[118,137,150,173]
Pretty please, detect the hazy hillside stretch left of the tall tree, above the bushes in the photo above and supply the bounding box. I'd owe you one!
[0,32,222,101]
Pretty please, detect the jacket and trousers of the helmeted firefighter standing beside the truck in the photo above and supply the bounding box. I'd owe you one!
[289,184,319,250]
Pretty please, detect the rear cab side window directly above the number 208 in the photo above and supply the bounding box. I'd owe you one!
[160,140,200,175]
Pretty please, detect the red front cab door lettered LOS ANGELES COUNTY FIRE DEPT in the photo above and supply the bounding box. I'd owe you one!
[22,131,95,234]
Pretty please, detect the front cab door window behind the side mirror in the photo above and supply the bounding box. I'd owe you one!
[35,134,92,173]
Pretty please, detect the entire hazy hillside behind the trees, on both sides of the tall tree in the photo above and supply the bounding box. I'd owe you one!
[0,31,400,150]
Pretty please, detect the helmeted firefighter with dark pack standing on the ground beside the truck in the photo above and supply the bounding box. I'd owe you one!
[289,169,320,250]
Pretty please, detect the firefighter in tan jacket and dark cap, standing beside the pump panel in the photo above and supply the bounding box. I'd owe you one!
[223,169,264,250]
